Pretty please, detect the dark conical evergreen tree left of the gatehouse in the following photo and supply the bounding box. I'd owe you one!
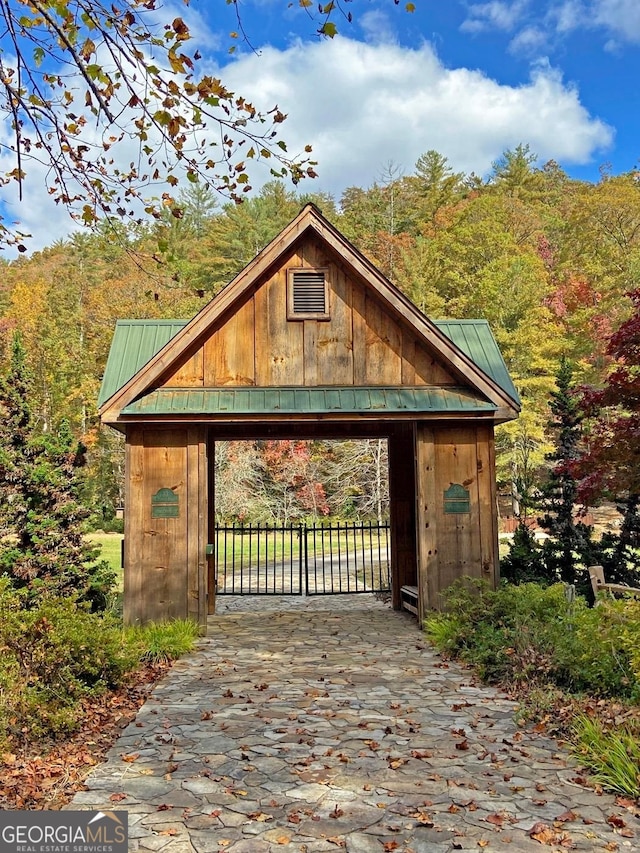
[0,335,114,608]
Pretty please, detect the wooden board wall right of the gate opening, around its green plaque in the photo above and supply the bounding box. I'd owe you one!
[417,424,498,618]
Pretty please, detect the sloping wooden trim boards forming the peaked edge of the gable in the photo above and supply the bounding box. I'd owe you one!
[100,205,519,424]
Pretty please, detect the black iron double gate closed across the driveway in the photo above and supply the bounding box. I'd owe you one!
[214,523,391,595]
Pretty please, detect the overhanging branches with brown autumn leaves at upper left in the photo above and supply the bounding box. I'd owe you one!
[0,0,315,249]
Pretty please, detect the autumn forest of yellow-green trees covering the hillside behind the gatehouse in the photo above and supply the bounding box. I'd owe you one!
[0,145,640,521]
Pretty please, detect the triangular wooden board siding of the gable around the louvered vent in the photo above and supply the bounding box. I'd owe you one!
[161,239,458,388]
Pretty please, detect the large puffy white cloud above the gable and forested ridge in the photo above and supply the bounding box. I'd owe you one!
[223,37,613,196]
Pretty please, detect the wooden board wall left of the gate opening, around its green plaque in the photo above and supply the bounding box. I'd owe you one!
[124,427,207,625]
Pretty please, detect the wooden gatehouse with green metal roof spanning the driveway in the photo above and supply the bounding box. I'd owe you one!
[99,205,520,629]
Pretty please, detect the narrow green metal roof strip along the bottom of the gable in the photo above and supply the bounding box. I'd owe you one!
[122,385,495,416]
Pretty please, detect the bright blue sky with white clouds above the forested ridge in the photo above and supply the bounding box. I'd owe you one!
[0,0,640,250]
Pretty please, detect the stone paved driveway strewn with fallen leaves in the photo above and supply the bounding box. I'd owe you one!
[69,595,640,853]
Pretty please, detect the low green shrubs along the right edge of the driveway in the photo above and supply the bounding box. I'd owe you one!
[425,579,640,699]
